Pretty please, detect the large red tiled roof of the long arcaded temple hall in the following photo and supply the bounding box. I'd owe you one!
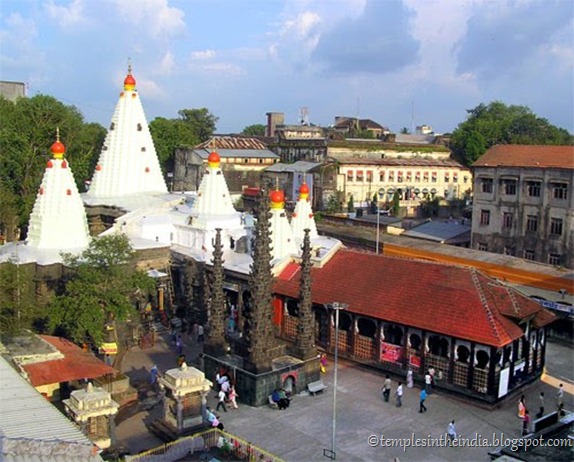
[275,250,547,347]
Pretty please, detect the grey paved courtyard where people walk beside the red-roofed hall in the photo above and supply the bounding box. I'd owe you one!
[117,334,574,461]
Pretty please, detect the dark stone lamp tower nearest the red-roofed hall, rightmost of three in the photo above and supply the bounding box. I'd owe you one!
[296,228,317,360]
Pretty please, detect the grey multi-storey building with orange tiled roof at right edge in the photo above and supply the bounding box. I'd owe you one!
[471,145,574,268]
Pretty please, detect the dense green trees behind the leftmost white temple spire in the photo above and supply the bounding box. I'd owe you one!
[0,95,106,237]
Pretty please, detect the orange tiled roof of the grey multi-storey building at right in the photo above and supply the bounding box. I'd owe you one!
[472,144,574,169]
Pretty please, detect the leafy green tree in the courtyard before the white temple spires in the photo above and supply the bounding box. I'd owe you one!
[48,235,155,345]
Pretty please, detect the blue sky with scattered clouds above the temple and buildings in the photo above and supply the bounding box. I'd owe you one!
[0,0,574,134]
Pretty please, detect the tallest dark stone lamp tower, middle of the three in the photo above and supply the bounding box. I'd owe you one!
[245,187,276,374]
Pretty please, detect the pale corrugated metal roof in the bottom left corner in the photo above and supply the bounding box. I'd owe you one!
[0,357,101,461]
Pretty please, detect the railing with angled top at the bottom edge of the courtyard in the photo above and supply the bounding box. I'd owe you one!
[125,428,284,462]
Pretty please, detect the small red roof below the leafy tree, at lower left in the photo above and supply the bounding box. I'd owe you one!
[22,335,118,387]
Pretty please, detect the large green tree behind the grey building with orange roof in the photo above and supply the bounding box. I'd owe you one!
[450,101,574,166]
